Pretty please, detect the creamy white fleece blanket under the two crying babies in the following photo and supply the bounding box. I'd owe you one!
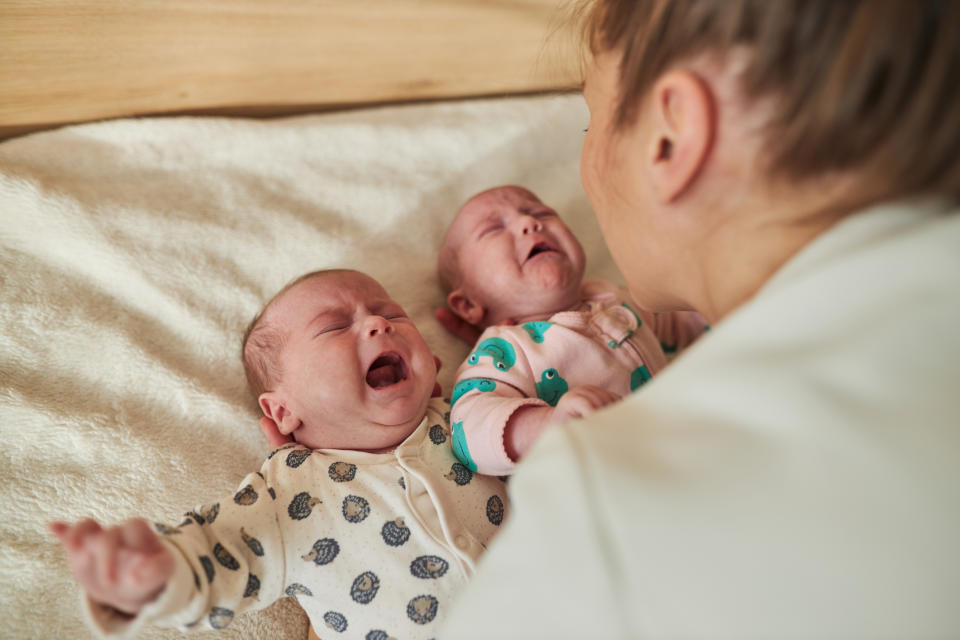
[0,95,619,639]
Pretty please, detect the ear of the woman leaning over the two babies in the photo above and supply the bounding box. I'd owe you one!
[648,69,717,204]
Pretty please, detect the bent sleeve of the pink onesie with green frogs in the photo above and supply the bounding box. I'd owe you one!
[450,327,547,475]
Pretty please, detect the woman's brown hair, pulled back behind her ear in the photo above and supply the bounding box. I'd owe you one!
[581,0,960,199]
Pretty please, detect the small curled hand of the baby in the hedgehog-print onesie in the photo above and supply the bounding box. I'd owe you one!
[49,519,174,615]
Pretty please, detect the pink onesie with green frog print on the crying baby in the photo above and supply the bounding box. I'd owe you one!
[450,280,708,475]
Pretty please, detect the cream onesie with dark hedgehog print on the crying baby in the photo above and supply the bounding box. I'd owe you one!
[88,398,507,640]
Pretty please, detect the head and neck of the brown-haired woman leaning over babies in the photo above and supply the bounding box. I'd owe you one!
[581,0,960,318]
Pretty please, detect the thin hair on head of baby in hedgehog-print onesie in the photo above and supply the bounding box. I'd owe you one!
[240,269,357,398]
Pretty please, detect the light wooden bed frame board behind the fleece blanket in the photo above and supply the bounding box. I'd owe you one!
[0,0,580,138]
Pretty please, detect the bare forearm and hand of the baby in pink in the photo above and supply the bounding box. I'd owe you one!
[503,384,620,461]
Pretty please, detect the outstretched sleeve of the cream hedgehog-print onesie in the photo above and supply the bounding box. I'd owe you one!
[86,465,285,638]
